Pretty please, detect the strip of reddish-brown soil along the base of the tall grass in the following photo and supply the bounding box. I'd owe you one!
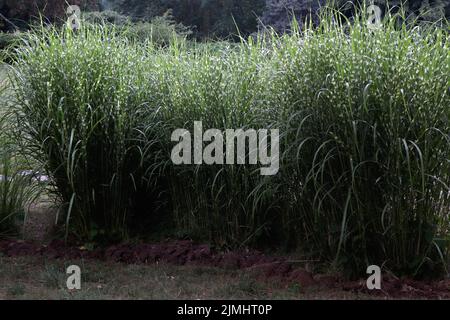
[0,240,450,299]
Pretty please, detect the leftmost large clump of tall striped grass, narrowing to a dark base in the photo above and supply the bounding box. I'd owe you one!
[9,27,164,241]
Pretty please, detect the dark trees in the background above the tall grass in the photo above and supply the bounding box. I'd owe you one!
[0,0,450,38]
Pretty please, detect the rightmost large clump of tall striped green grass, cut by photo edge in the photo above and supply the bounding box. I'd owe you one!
[278,11,450,274]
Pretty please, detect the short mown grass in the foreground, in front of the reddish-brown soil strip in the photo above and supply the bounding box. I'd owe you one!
[0,257,376,300]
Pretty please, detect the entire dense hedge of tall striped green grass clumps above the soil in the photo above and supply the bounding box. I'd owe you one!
[8,10,450,274]
